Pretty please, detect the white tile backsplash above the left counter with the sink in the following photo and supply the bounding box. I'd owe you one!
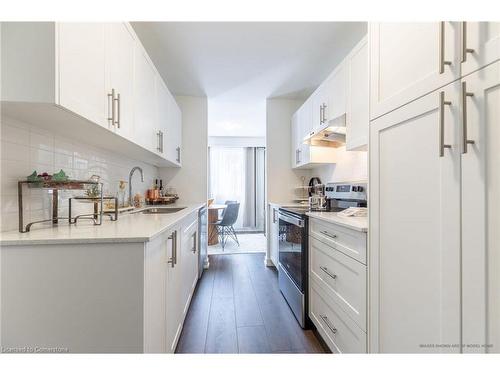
[0,117,158,231]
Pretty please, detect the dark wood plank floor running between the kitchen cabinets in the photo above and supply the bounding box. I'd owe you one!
[177,253,324,353]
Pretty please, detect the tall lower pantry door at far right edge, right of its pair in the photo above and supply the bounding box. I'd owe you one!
[461,62,500,353]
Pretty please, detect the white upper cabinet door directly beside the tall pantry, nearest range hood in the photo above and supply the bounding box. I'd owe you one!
[346,38,370,151]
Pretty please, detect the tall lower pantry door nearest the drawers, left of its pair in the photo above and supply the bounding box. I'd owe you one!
[369,83,461,353]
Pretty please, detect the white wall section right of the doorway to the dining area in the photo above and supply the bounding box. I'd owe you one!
[266,99,310,203]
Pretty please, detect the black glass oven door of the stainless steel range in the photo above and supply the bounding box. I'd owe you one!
[279,211,306,292]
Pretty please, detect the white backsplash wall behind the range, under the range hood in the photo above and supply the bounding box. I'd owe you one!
[311,147,368,183]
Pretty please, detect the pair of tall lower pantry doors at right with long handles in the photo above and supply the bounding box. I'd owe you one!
[369,63,500,353]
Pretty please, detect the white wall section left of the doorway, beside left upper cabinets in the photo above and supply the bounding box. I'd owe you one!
[160,96,208,203]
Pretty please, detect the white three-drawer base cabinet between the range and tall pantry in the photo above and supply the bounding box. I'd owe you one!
[309,218,367,353]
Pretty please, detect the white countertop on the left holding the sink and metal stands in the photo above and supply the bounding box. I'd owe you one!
[0,202,206,246]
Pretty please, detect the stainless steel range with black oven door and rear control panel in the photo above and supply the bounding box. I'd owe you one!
[278,182,367,328]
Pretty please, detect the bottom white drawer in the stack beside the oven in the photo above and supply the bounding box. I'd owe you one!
[309,282,366,353]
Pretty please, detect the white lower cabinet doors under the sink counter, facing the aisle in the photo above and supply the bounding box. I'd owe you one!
[144,213,198,353]
